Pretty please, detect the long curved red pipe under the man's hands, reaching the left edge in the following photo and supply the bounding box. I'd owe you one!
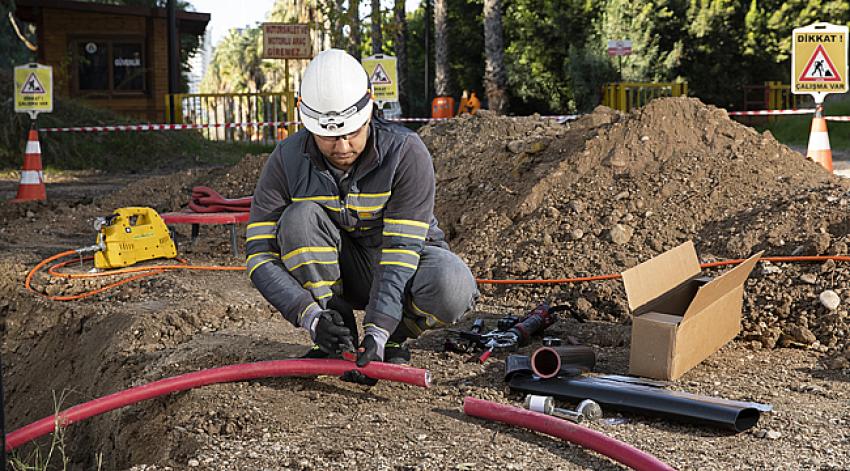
[6,359,431,451]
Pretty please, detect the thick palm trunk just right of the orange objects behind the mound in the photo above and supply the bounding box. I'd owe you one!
[484,0,508,114]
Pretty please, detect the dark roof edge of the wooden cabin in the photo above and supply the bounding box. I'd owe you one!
[15,0,210,36]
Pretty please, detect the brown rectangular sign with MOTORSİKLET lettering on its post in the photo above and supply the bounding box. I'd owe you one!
[263,23,313,134]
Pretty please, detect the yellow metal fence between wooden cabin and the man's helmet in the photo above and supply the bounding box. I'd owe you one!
[165,92,297,144]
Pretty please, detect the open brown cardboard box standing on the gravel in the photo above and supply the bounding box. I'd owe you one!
[623,241,762,379]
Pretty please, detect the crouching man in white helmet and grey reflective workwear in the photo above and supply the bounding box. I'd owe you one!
[246,49,478,384]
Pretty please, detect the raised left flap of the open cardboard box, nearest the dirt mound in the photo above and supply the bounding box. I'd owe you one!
[622,241,700,312]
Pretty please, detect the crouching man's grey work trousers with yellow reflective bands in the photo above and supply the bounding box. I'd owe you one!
[277,202,479,338]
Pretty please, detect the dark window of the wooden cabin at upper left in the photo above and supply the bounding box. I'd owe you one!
[73,39,145,94]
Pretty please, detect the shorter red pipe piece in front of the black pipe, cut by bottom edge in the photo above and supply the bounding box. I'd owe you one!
[463,397,675,471]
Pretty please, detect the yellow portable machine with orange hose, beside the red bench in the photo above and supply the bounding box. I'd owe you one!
[94,207,177,268]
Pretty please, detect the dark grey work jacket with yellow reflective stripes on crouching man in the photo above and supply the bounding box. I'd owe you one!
[246,117,444,333]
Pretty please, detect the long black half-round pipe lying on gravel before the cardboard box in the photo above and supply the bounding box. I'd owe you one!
[509,374,771,432]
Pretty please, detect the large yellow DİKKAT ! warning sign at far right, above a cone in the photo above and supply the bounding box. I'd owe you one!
[791,23,848,97]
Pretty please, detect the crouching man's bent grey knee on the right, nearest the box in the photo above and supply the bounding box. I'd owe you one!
[411,246,479,327]
